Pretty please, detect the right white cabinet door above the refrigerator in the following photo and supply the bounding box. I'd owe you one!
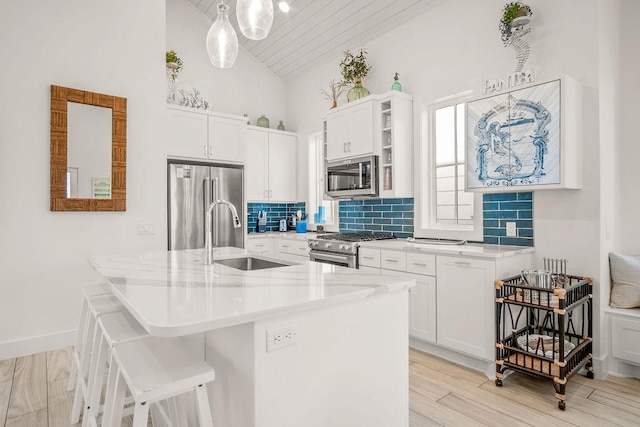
[209,116,244,163]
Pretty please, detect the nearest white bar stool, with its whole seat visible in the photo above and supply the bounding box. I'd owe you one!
[102,337,215,427]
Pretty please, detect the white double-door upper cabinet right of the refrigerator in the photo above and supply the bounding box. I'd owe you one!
[245,128,298,202]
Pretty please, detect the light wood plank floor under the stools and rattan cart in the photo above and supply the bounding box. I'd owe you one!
[0,348,640,427]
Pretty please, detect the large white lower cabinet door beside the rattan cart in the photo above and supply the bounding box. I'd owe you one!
[436,256,495,360]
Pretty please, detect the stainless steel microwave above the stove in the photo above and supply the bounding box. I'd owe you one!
[325,156,378,199]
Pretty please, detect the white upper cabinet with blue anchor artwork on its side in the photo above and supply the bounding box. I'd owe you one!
[466,77,582,192]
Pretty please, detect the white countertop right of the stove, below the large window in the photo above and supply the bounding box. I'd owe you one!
[358,239,535,258]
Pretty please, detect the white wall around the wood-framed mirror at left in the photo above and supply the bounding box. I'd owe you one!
[0,0,166,359]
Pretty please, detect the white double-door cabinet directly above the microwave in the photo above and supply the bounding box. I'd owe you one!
[327,98,376,161]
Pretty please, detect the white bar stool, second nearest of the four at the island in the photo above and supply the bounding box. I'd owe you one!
[82,307,149,426]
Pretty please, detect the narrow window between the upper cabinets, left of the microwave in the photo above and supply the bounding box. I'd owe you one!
[307,132,338,231]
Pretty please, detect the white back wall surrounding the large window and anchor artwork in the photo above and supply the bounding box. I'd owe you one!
[287,0,599,277]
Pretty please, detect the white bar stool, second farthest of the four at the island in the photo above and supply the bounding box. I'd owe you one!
[71,295,124,424]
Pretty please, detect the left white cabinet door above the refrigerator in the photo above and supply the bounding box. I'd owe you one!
[166,108,207,159]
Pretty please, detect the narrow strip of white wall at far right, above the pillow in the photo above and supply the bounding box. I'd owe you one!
[620,0,640,255]
